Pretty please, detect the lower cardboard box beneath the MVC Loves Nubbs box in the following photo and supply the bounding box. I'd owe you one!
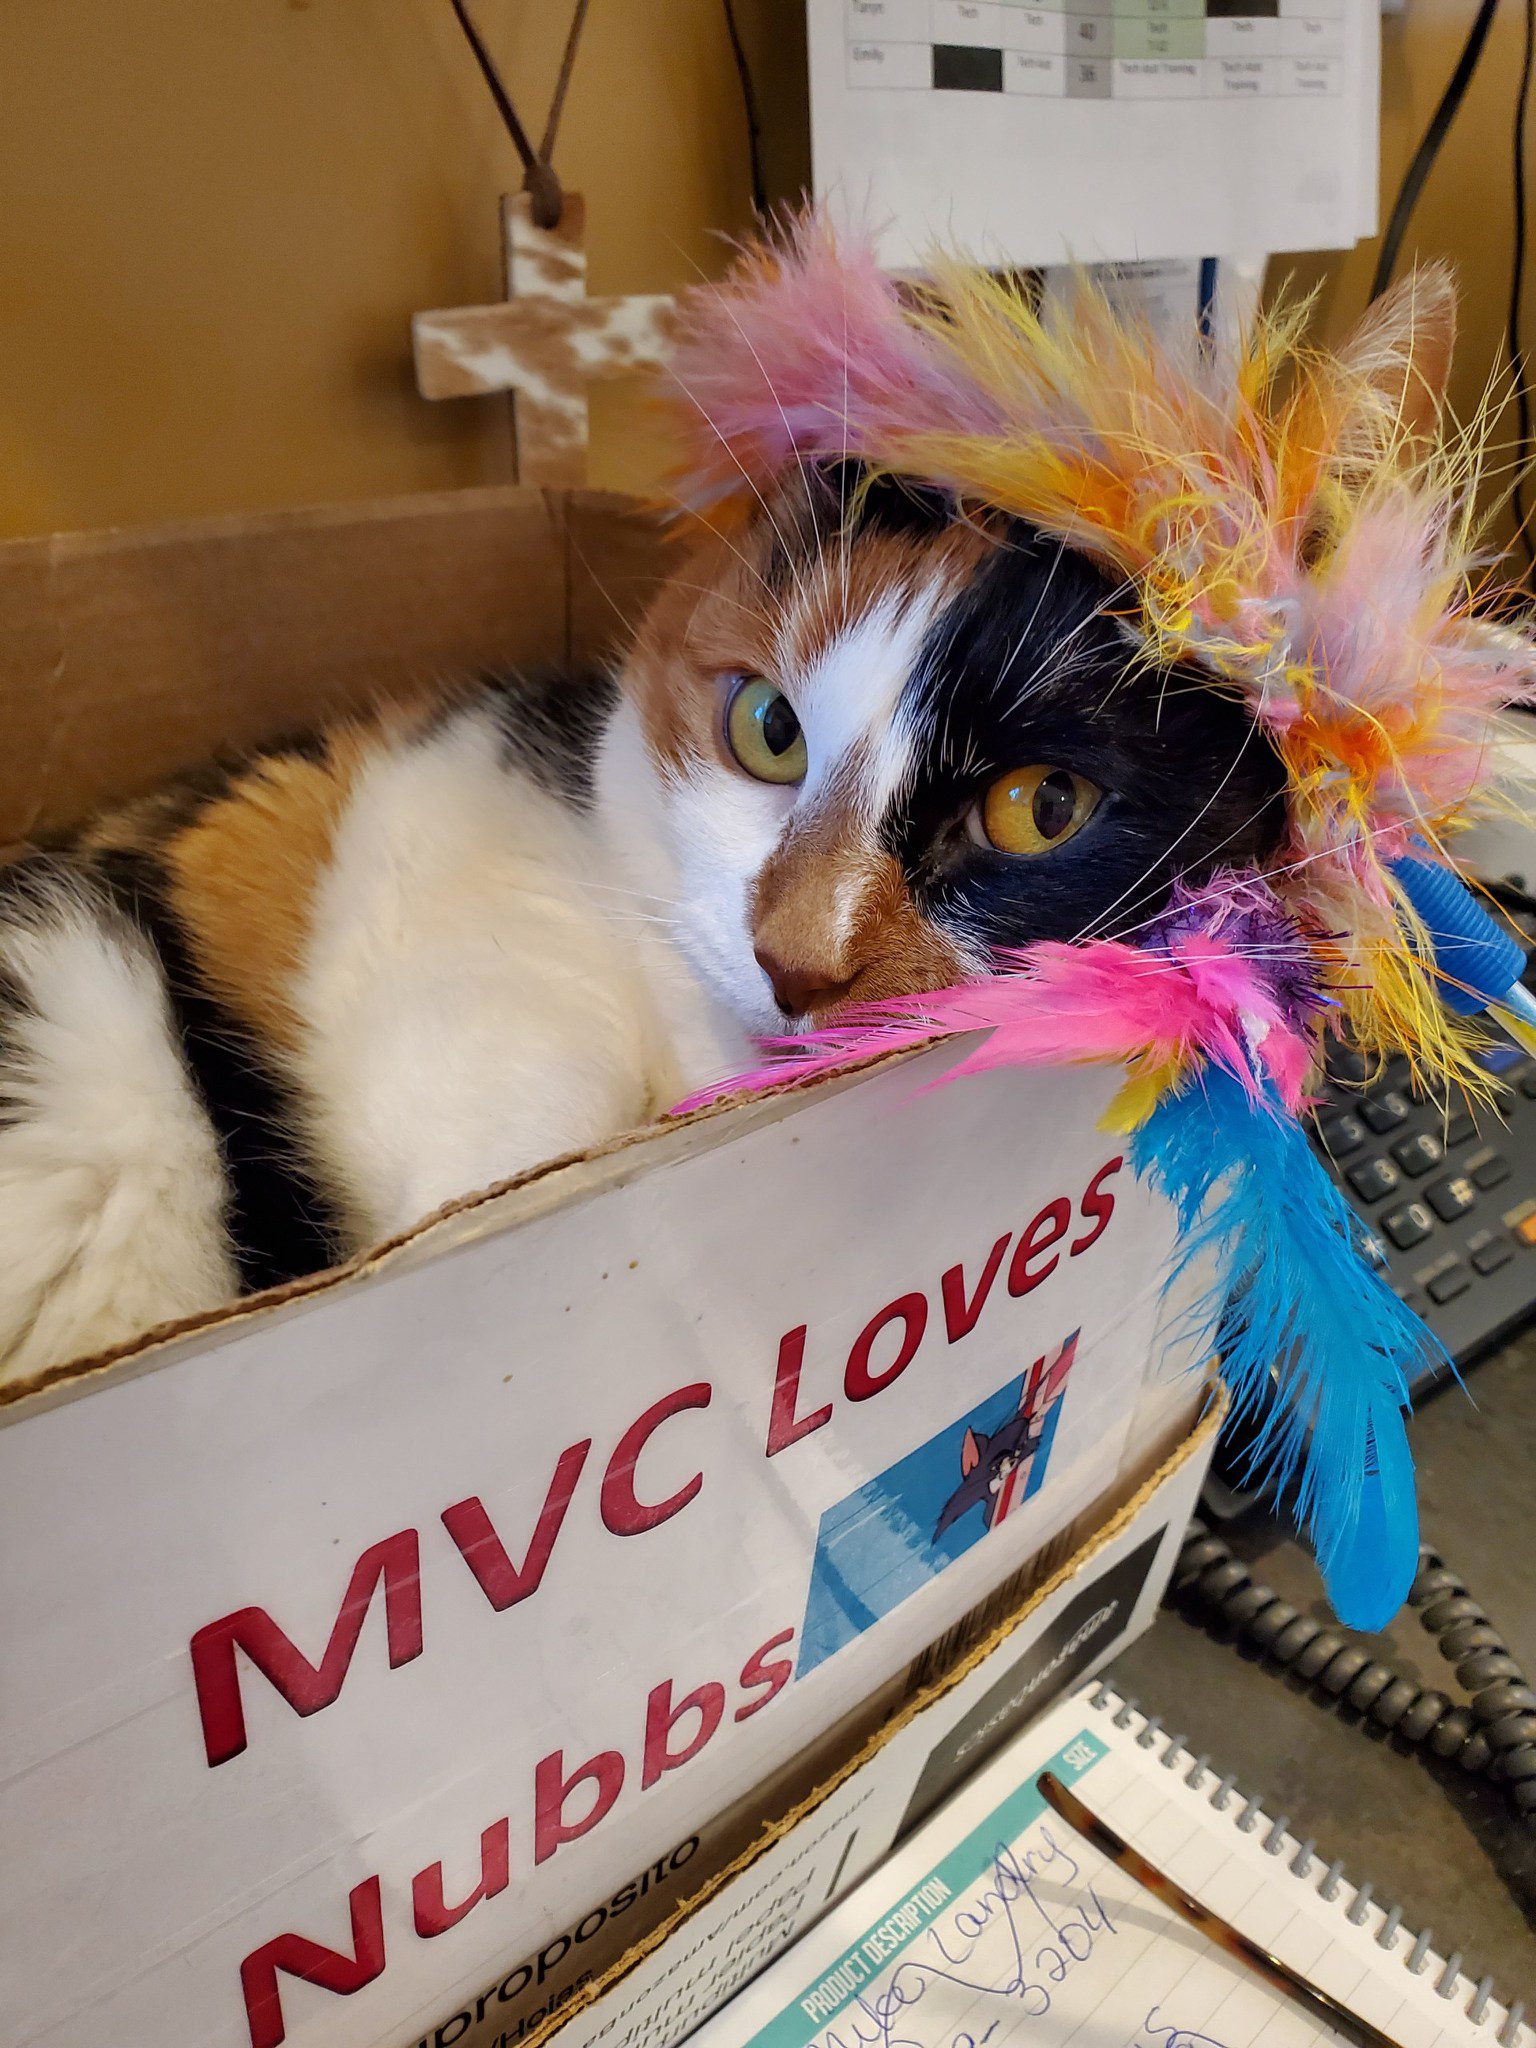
[436,1409,1221,2048]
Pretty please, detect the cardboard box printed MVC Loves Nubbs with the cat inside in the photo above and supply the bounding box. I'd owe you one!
[0,494,1198,2048]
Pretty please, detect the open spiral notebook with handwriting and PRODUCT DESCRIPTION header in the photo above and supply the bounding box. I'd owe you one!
[690,1686,1536,2048]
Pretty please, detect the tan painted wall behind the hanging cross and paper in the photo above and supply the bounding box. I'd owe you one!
[0,0,1536,532]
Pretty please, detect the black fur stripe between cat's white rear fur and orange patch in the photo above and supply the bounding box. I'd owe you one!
[90,850,340,1292]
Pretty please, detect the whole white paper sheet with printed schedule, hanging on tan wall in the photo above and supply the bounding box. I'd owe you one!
[809,0,1380,268]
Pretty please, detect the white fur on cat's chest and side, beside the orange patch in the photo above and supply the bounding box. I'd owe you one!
[293,692,750,1243]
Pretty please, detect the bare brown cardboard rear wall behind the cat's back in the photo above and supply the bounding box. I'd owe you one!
[0,487,662,848]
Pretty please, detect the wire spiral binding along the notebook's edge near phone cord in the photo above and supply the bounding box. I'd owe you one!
[1087,1679,1536,2048]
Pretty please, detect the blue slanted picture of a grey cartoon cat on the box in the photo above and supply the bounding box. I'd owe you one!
[795,1329,1079,1677]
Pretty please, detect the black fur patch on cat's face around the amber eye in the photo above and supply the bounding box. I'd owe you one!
[885,522,1284,948]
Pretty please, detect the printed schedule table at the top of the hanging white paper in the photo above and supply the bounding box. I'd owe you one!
[842,0,1346,100]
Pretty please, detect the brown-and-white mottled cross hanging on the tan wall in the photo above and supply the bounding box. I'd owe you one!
[412,193,672,489]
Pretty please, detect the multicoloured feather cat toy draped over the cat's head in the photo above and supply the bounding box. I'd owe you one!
[678,217,1536,1628]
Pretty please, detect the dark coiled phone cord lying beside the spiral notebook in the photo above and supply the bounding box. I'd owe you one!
[1167,1518,1536,1827]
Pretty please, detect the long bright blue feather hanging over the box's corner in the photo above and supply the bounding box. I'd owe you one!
[1130,1065,1444,1628]
